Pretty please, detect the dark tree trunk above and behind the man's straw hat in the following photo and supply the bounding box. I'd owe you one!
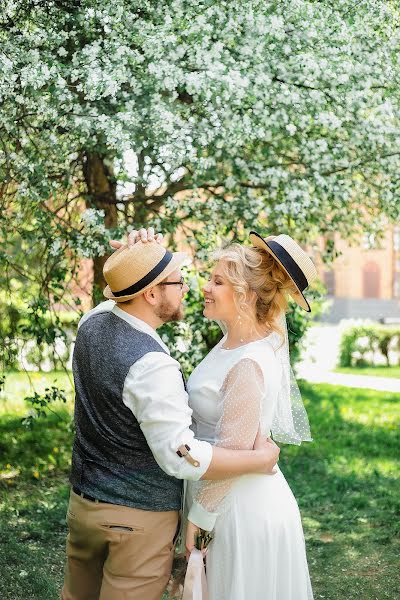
[83,152,118,306]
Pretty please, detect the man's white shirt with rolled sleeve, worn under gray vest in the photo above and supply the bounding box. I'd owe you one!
[79,300,212,481]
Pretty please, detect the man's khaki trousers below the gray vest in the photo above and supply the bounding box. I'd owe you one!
[61,490,178,600]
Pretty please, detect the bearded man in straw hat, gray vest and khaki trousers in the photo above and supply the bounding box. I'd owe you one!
[62,231,279,600]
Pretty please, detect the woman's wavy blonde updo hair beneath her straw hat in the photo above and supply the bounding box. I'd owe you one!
[212,244,296,337]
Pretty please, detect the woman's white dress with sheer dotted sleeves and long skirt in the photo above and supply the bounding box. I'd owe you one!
[186,334,313,600]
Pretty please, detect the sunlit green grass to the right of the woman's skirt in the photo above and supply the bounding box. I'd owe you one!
[281,385,400,600]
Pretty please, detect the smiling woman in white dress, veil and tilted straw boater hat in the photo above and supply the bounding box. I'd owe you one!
[186,232,316,600]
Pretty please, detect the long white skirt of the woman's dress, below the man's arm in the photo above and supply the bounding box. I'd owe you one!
[188,468,313,600]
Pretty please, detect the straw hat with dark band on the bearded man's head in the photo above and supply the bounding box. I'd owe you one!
[103,241,188,302]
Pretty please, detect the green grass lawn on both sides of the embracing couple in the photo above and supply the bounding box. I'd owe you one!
[0,374,400,600]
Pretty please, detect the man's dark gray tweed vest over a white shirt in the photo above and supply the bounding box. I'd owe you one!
[70,312,182,511]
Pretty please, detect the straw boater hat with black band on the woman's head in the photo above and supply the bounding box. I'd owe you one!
[250,231,317,312]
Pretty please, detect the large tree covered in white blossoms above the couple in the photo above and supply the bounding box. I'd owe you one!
[0,0,400,372]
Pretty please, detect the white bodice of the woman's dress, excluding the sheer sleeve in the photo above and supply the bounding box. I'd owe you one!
[188,333,282,443]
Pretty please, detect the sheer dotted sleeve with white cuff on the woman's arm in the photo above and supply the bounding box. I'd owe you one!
[188,358,264,531]
